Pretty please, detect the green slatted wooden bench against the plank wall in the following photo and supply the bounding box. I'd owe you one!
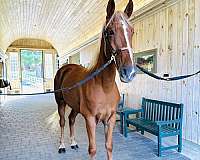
[124,98,183,156]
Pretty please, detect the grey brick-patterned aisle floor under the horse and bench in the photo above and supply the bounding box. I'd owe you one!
[0,95,189,160]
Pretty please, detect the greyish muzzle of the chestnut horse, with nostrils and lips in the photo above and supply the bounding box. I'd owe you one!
[119,66,137,83]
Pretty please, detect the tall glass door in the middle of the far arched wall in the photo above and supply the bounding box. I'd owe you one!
[20,49,44,93]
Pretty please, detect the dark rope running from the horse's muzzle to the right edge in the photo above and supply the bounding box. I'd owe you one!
[136,64,200,81]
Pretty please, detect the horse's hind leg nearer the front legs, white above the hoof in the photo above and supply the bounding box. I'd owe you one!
[68,109,78,149]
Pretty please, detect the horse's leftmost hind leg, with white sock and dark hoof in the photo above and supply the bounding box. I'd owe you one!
[58,102,66,153]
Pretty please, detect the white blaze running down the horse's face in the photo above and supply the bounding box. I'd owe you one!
[121,15,133,64]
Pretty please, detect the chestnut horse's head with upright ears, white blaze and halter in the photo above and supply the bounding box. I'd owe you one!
[103,0,136,83]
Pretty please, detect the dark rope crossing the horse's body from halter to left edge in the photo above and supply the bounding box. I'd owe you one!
[0,56,115,96]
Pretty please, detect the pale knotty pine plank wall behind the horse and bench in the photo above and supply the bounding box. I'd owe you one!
[60,0,200,144]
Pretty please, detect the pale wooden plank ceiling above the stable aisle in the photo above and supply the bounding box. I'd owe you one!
[0,0,152,55]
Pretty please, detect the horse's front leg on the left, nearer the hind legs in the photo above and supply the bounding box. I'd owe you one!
[85,117,96,160]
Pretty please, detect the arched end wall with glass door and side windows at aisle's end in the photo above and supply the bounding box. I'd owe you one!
[6,39,57,93]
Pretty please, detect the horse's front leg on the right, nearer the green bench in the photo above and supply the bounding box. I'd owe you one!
[104,113,116,160]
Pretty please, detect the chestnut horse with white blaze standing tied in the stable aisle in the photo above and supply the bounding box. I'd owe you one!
[54,0,136,160]
